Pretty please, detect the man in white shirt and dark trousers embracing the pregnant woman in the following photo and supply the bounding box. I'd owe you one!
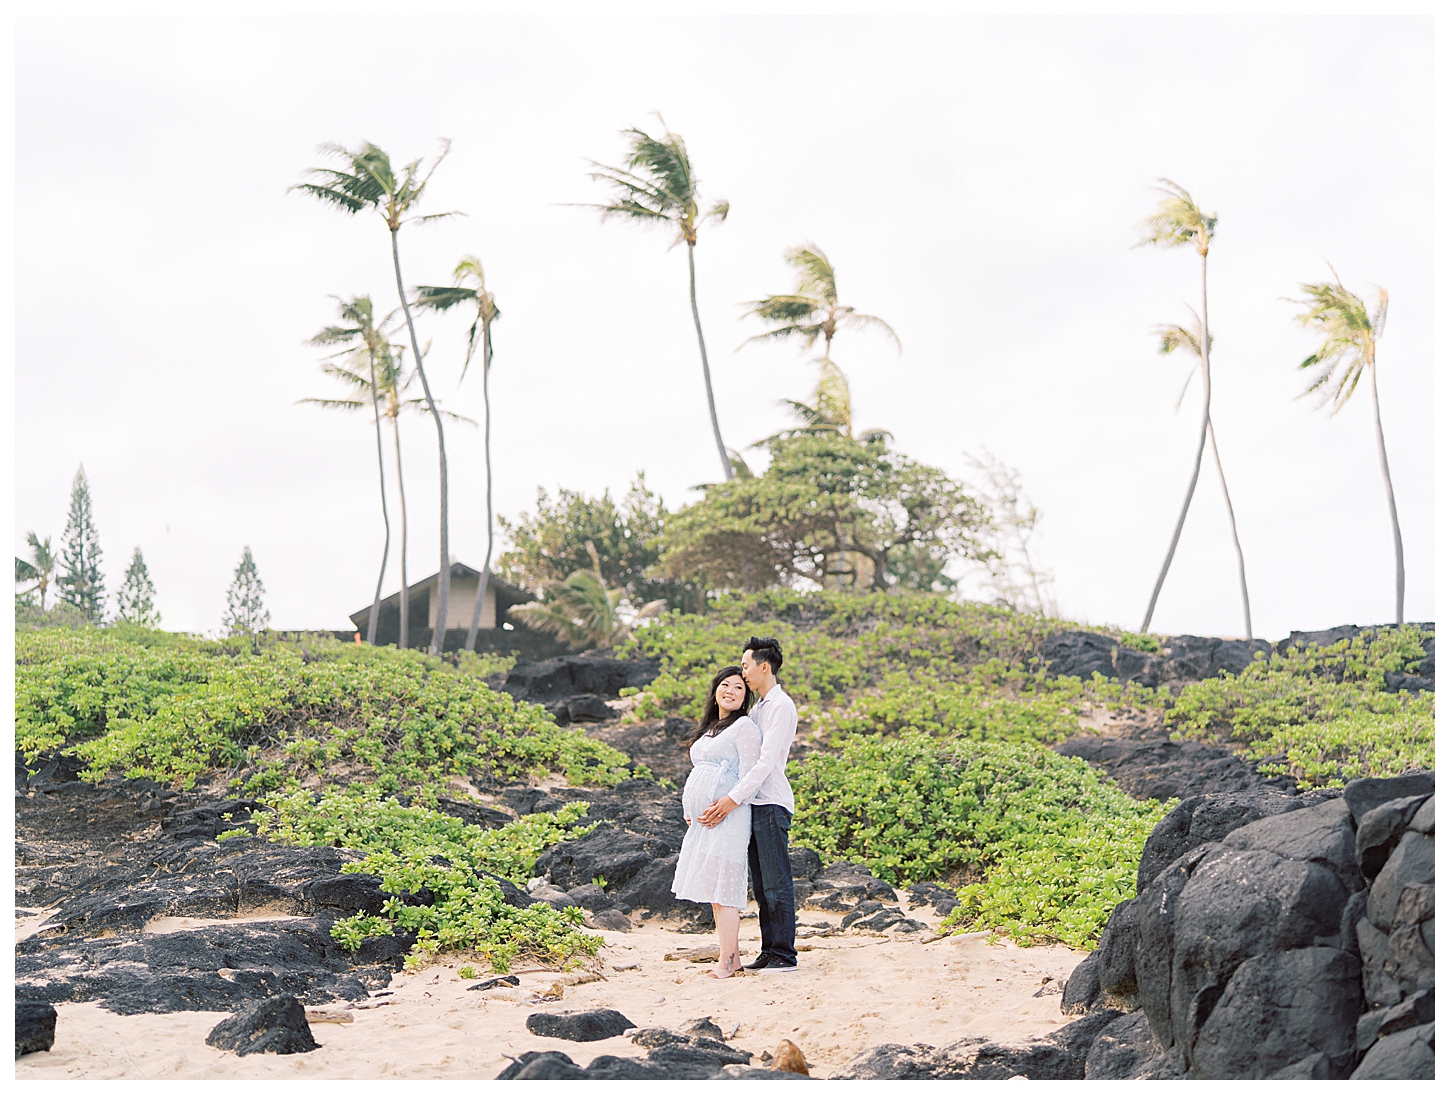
[700,637,796,973]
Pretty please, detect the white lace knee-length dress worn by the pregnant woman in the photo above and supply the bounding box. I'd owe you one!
[671,718,760,909]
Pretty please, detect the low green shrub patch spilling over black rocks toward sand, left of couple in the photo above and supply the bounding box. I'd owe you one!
[257,785,602,973]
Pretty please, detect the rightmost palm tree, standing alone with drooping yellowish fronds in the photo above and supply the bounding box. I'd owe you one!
[1295,267,1405,624]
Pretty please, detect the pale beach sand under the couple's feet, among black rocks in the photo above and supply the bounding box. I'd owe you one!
[15,909,1082,1079]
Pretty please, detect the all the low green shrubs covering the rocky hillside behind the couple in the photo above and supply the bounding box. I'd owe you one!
[16,592,1434,969]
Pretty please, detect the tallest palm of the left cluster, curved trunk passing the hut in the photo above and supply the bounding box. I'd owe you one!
[300,141,455,654]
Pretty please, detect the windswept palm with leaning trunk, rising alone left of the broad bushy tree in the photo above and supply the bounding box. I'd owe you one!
[589,113,735,479]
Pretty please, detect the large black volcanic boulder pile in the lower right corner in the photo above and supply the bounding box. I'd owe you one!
[1063,773,1434,1079]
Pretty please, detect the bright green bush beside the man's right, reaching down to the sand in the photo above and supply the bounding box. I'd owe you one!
[790,732,1175,946]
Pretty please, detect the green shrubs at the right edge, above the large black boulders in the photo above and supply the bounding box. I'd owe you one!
[1167,625,1436,788]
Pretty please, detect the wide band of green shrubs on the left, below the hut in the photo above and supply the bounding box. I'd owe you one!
[16,628,629,796]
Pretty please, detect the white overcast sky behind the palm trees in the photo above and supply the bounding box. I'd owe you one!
[15,10,1434,638]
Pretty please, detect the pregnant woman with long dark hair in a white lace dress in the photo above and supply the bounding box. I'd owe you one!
[671,666,760,978]
